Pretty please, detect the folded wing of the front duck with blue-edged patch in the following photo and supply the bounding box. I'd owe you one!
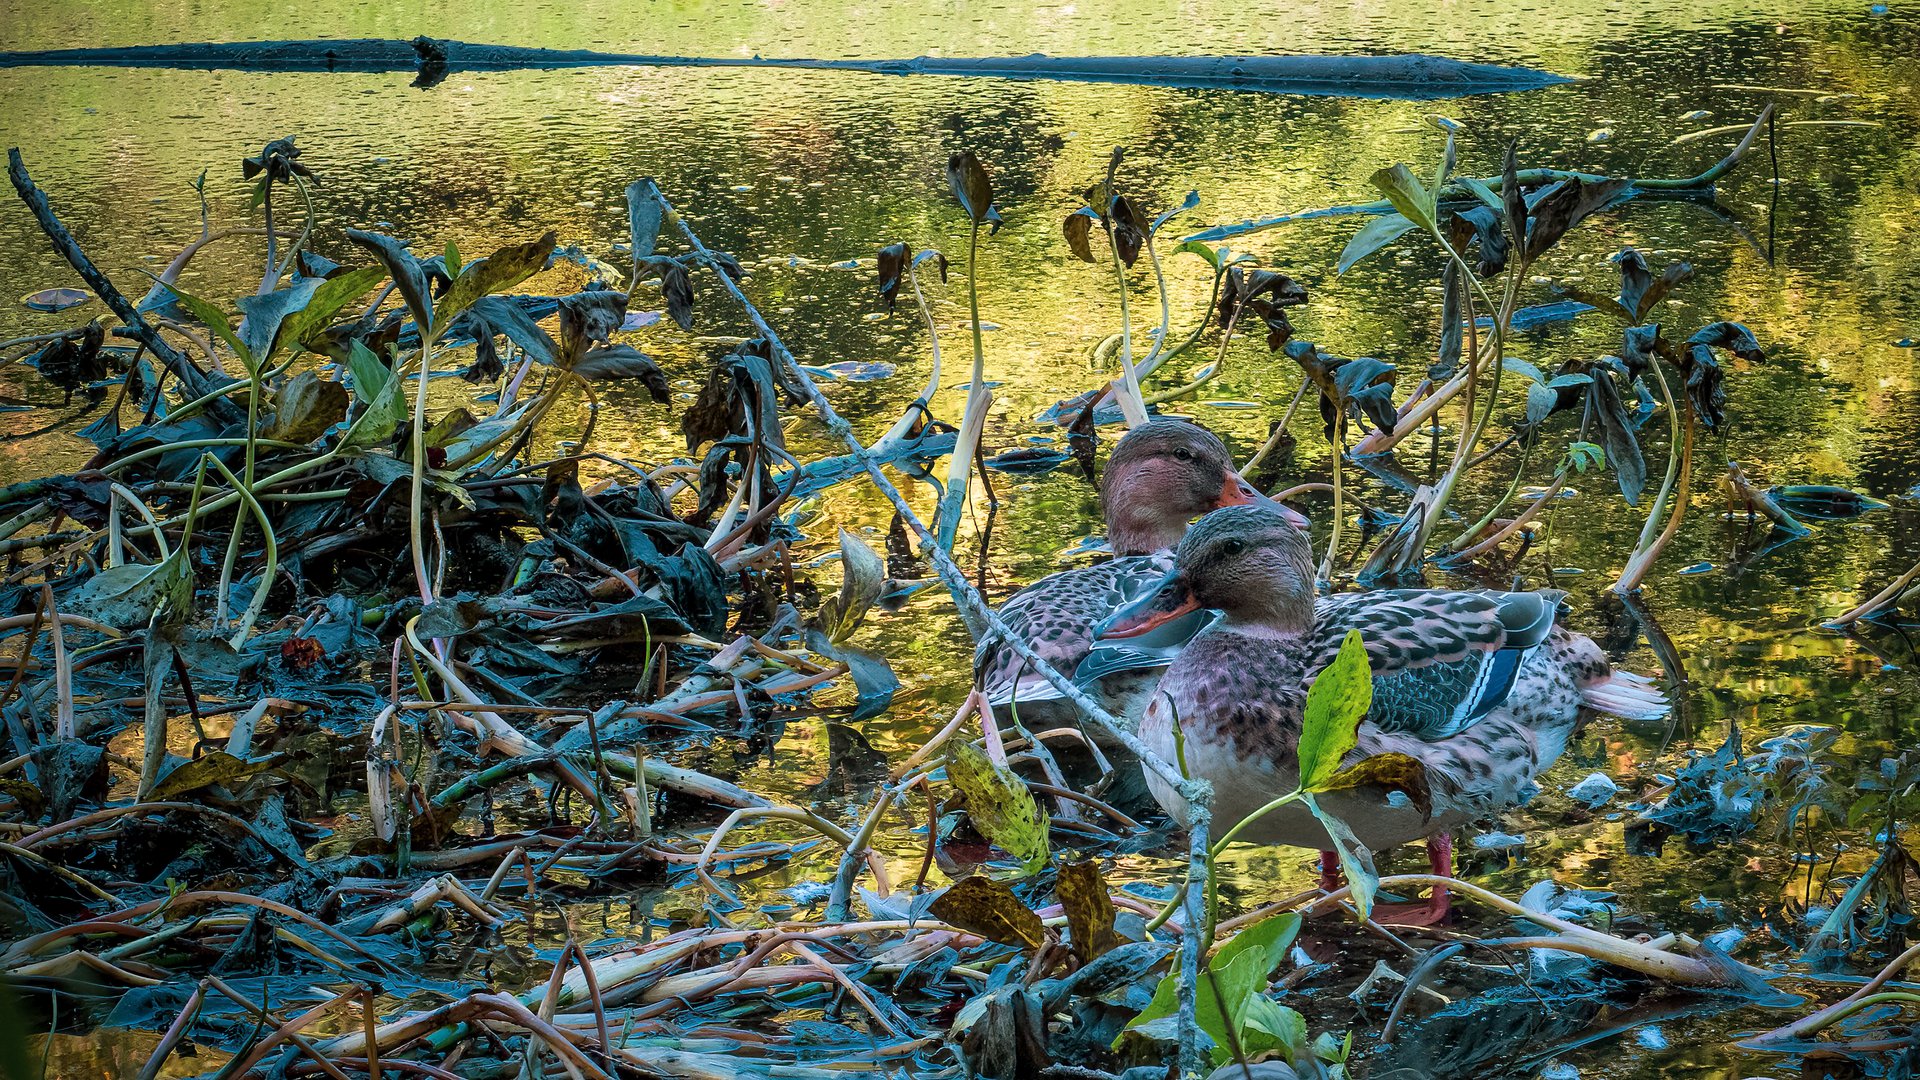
[1309,590,1563,740]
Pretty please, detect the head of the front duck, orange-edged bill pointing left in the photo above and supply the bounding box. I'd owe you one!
[1094,505,1313,638]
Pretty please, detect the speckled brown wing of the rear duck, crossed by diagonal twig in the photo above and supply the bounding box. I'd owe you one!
[973,552,1167,705]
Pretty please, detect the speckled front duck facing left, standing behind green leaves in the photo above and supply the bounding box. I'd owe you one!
[1108,507,1667,849]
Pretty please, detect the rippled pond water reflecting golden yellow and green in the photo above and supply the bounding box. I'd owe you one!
[0,0,1920,1078]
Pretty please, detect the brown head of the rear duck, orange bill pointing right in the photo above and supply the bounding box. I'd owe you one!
[1100,419,1308,555]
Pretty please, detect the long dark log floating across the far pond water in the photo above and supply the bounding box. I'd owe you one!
[0,37,1567,98]
